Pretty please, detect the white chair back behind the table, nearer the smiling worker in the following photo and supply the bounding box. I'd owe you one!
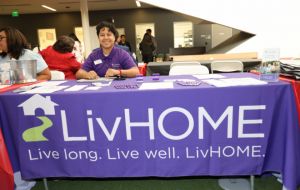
[169,62,209,75]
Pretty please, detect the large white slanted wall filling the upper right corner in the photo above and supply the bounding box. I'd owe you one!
[141,0,300,57]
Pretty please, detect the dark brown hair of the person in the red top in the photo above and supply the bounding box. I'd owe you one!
[52,36,75,53]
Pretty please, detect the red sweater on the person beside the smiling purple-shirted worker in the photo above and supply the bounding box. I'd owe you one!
[40,46,81,80]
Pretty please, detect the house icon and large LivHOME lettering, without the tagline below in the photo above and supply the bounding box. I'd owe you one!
[18,94,267,145]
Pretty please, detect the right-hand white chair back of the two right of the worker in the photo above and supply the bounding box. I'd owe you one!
[210,60,244,73]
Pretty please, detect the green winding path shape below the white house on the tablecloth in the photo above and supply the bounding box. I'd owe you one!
[22,116,53,142]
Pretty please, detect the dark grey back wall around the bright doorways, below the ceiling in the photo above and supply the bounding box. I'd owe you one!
[0,8,210,57]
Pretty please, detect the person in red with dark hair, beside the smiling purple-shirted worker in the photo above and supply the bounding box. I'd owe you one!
[40,36,81,80]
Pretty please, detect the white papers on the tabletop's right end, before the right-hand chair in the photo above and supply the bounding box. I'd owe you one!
[203,77,268,87]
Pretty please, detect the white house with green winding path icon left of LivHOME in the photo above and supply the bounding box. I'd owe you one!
[18,94,58,142]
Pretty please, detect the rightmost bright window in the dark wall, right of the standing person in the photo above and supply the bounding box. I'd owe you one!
[173,22,193,48]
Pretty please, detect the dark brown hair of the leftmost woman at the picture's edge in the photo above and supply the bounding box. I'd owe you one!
[0,27,28,59]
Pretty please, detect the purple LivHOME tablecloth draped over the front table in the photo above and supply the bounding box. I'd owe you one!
[0,74,300,190]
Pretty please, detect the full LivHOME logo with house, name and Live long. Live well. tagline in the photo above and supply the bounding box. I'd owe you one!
[18,94,268,162]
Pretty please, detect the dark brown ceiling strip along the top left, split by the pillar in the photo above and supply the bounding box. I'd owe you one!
[0,0,152,15]
